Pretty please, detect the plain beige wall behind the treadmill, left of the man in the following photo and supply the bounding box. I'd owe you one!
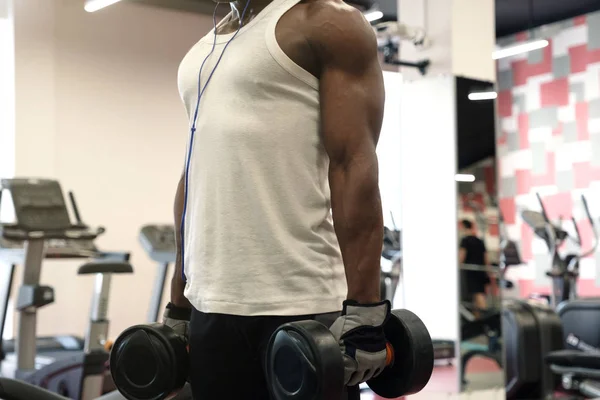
[9,0,212,337]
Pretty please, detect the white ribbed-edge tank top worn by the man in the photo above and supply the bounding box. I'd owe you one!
[178,0,347,316]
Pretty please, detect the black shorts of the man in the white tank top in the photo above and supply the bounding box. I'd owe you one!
[190,310,360,400]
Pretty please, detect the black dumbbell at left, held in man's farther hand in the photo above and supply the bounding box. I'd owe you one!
[110,323,189,400]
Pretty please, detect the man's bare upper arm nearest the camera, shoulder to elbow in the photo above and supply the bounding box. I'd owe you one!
[311,6,385,165]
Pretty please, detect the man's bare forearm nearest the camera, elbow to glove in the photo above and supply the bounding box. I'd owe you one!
[330,165,383,303]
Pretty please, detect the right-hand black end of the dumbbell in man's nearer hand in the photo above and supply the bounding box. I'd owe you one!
[367,310,434,399]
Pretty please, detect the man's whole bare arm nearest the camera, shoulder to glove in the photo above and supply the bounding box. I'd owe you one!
[309,0,385,303]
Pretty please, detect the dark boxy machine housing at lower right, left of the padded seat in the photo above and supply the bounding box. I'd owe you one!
[502,300,563,399]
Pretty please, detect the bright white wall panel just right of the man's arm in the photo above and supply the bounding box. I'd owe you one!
[400,76,459,346]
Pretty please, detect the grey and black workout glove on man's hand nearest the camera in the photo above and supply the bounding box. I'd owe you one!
[330,300,391,386]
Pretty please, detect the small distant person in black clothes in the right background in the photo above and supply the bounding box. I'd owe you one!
[458,219,490,315]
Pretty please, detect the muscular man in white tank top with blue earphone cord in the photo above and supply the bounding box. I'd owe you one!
[165,0,390,400]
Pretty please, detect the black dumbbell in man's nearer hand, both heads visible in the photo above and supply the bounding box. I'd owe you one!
[266,310,433,400]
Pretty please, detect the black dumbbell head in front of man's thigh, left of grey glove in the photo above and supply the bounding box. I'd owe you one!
[266,320,344,400]
